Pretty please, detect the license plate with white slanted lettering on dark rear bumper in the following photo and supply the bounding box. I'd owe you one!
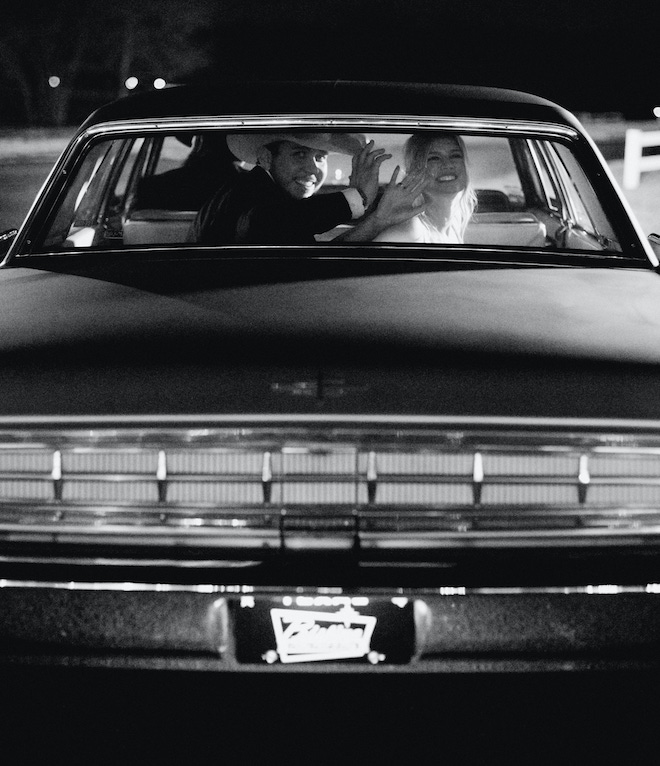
[234,595,415,665]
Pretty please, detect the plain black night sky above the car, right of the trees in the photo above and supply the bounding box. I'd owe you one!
[205,0,660,119]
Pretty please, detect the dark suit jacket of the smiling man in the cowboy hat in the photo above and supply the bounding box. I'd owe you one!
[191,167,351,245]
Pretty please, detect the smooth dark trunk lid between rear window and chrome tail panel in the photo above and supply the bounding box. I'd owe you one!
[0,262,660,418]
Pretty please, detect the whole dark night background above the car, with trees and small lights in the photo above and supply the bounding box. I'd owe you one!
[0,0,660,125]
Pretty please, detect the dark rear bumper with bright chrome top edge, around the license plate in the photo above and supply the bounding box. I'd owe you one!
[0,580,660,673]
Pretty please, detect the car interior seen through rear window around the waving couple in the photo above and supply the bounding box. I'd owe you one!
[38,132,620,252]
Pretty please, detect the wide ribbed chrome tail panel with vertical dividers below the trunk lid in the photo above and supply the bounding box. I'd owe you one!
[0,415,660,566]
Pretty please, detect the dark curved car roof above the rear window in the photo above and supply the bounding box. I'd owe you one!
[81,80,579,130]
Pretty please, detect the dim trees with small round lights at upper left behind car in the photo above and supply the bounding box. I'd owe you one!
[0,0,217,126]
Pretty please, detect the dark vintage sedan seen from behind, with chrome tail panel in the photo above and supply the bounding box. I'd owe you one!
[0,82,660,700]
